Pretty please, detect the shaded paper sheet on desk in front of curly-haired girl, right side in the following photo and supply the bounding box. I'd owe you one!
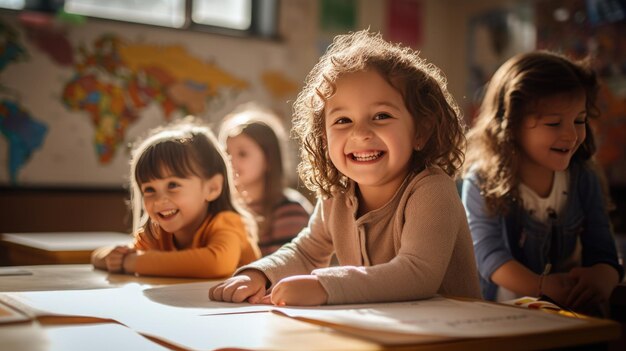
[275,297,586,338]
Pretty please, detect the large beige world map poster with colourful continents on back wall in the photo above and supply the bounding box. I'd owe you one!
[0,15,298,188]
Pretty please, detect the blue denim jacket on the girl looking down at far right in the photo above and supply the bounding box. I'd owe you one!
[462,162,624,300]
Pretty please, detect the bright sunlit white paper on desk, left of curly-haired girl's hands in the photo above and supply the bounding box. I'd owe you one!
[0,282,275,350]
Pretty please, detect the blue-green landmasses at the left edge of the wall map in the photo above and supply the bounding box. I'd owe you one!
[0,22,48,184]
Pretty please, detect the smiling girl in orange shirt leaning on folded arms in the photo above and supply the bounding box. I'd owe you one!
[91,120,260,278]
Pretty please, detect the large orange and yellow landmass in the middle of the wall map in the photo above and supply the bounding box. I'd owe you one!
[63,35,249,164]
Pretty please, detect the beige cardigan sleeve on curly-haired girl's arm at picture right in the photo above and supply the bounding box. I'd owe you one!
[302,172,472,304]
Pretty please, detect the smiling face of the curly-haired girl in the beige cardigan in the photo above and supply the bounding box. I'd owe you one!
[324,69,419,201]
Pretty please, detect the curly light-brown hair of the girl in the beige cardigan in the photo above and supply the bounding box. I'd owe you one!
[292,30,465,198]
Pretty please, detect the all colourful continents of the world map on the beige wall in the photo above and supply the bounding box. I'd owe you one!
[0,20,297,184]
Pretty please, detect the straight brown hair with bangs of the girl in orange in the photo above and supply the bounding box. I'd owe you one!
[130,117,257,242]
